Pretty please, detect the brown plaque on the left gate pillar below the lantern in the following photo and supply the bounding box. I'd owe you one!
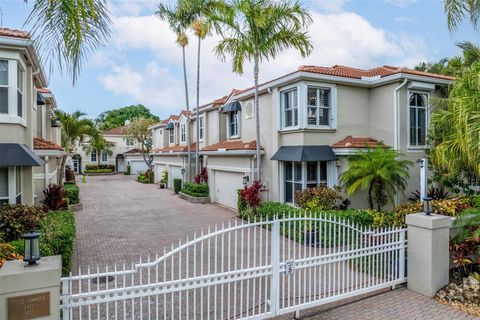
[7,292,50,320]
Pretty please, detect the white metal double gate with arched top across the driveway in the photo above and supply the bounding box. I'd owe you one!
[61,214,406,320]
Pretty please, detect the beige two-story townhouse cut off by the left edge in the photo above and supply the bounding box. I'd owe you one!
[0,28,63,206]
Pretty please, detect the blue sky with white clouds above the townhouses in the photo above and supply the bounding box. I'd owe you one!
[0,0,480,119]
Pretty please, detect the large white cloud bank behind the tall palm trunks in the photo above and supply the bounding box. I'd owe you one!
[99,12,428,116]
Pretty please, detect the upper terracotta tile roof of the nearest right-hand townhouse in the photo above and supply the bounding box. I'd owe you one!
[298,65,455,80]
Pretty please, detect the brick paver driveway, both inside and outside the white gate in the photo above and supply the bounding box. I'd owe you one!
[73,175,476,320]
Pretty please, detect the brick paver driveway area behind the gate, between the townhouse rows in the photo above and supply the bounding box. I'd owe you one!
[73,174,236,271]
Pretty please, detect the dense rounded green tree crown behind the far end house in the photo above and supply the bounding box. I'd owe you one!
[95,104,160,130]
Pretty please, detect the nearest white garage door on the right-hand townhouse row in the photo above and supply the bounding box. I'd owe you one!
[213,171,243,208]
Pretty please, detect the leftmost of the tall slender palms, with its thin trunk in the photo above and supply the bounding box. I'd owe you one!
[155,3,198,181]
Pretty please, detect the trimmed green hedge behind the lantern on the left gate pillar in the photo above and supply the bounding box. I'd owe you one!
[11,210,75,275]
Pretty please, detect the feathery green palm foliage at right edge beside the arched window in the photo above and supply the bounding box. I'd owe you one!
[429,62,480,180]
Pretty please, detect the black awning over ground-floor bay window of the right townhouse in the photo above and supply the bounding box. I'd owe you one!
[270,146,337,161]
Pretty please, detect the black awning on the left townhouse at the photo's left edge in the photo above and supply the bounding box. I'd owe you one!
[0,143,43,167]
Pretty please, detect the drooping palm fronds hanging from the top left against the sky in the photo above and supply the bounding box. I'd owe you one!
[24,0,111,84]
